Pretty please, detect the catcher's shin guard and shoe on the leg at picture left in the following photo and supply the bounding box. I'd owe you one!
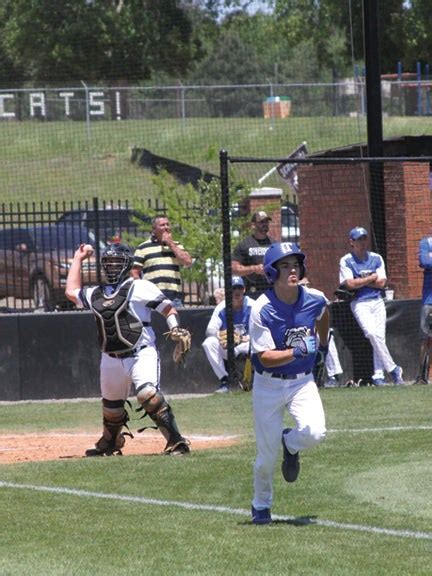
[85,398,132,456]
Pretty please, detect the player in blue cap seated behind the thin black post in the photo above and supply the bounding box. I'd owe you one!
[202,276,252,393]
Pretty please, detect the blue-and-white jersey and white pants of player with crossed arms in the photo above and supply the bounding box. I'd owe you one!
[339,252,396,380]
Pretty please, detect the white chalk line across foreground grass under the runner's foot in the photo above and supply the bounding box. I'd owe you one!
[0,480,432,540]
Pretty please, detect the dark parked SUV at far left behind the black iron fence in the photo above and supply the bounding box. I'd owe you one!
[0,223,104,311]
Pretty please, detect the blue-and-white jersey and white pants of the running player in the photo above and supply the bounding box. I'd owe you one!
[249,286,327,510]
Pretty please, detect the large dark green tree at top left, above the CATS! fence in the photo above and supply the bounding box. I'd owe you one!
[0,0,194,83]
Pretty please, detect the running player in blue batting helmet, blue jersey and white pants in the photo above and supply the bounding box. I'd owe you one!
[249,242,329,524]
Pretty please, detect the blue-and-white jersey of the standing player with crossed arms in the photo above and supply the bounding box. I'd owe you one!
[339,252,387,300]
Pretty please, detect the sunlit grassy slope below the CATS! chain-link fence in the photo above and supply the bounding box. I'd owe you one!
[0,117,432,202]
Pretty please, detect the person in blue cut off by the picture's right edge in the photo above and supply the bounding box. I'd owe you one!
[416,236,432,384]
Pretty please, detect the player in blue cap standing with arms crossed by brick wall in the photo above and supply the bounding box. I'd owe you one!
[339,226,404,386]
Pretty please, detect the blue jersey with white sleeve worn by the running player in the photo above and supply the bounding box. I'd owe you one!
[249,286,327,376]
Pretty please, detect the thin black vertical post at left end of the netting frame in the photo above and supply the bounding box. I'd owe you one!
[219,150,236,386]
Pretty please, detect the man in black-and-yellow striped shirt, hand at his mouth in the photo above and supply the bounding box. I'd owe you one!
[132,215,192,307]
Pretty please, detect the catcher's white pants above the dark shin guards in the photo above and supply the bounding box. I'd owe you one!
[100,346,160,400]
